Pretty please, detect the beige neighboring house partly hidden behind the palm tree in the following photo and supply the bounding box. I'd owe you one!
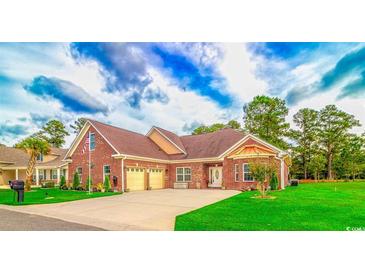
[0,146,68,185]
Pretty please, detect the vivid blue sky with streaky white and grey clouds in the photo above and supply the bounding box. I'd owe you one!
[0,43,365,147]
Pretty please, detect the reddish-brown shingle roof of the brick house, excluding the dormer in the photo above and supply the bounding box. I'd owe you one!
[89,120,245,160]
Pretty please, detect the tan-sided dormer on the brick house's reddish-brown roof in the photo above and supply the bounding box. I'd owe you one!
[146,126,186,155]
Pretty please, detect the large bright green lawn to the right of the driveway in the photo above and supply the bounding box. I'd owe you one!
[175,182,365,231]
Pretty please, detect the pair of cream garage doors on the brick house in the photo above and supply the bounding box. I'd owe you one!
[126,167,165,191]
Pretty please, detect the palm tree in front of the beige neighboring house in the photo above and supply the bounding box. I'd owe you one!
[15,136,50,191]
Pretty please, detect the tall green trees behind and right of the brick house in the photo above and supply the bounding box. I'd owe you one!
[192,96,365,180]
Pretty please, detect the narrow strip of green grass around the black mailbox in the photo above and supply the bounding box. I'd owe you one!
[0,188,120,205]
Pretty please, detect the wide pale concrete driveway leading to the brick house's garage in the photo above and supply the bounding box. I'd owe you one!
[2,189,239,230]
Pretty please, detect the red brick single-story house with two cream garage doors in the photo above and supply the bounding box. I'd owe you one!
[65,120,290,191]
